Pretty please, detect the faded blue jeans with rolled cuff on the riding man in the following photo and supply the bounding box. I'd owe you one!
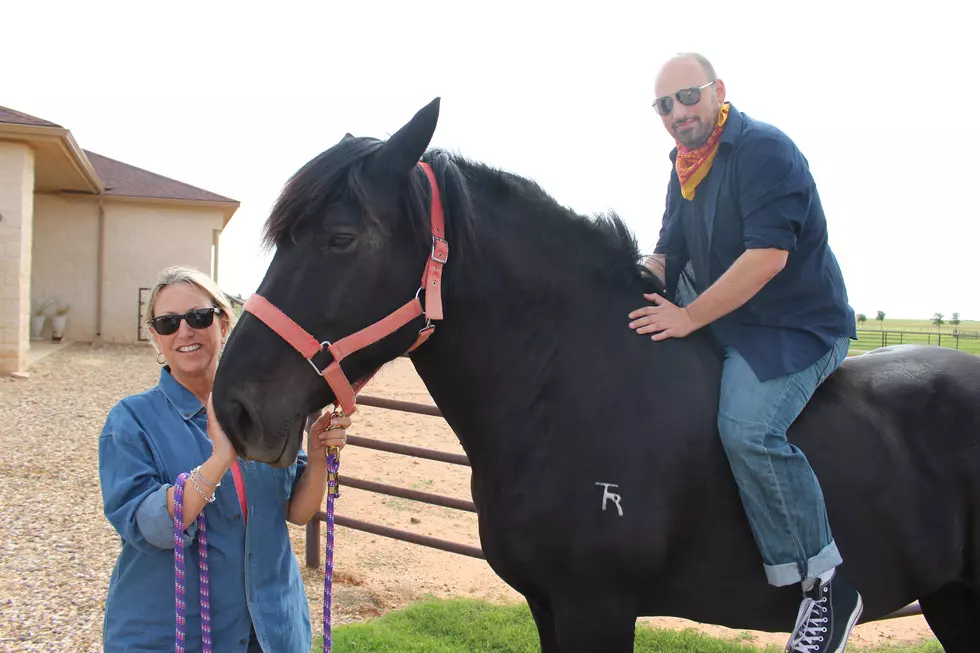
[718,336,850,586]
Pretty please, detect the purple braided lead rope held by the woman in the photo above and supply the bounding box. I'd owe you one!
[174,447,340,653]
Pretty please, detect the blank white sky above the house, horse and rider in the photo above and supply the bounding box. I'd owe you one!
[0,0,980,319]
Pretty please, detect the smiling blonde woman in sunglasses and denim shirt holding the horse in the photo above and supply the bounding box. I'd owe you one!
[99,267,350,653]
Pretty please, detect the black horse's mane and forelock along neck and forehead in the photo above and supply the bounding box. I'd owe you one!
[263,135,663,292]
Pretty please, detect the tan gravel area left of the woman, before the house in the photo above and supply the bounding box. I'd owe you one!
[0,344,159,653]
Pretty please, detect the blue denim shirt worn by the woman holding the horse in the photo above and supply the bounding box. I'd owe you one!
[99,367,312,653]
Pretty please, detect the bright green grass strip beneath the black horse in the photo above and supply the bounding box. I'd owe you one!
[313,599,942,653]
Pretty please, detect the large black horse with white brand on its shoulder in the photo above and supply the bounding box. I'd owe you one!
[213,99,980,653]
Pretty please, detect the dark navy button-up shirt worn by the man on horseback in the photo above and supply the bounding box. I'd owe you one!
[654,106,857,381]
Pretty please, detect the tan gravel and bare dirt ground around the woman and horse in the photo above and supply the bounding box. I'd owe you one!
[0,344,931,653]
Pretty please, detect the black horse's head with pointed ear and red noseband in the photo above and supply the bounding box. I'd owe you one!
[213,98,448,465]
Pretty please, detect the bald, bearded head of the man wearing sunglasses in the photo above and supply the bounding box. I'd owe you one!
[655,53,725,148]
